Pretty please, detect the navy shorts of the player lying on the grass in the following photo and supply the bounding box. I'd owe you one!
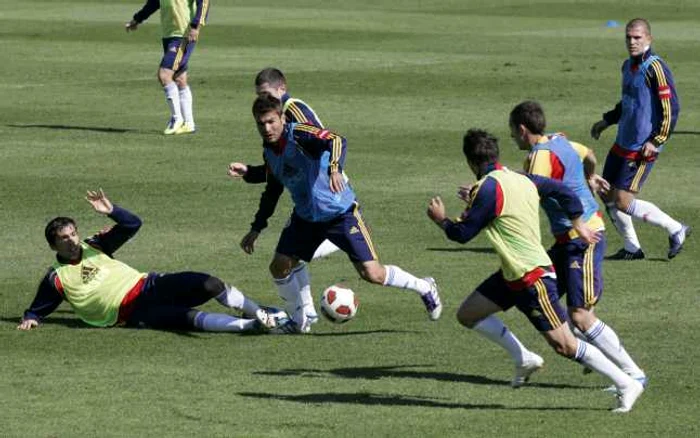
[127,272,211,330]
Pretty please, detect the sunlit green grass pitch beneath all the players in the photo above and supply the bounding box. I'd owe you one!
[0,0,700,437]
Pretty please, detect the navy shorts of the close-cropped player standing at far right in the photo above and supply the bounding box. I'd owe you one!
[603,145,656,193]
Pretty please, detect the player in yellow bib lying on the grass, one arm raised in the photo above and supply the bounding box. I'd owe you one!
[17,189,276,332]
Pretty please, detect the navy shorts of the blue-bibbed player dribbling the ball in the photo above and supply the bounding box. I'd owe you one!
[276,203,377,263]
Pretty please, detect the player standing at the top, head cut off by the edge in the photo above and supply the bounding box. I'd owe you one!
[126,0,209,135]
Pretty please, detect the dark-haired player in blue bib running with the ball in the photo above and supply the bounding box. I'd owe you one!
[228,94,442,333]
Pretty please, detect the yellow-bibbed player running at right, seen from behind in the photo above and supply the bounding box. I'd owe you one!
[428,129,644,412]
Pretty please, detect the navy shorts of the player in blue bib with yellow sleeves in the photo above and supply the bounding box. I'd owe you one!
[549,233,607,309]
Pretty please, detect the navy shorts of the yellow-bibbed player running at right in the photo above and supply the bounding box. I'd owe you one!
[476,271,567,332]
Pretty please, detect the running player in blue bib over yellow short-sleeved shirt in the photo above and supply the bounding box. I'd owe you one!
[509,101,646,385]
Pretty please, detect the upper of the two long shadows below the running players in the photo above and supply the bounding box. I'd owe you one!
[253,365,587,389]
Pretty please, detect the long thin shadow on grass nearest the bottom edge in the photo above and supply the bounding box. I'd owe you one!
[238,392,603,411]
